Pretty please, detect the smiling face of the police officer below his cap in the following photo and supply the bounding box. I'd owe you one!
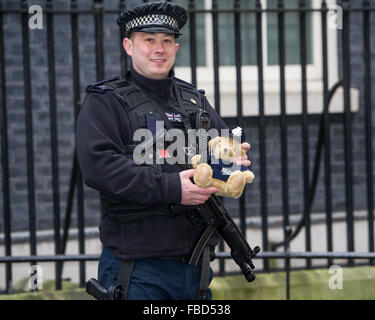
[123,32,178,79]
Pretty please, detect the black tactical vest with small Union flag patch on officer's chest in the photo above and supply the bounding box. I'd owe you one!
[86,73,217,259]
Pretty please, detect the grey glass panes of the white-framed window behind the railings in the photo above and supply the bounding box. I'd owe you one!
[176,0,312,66]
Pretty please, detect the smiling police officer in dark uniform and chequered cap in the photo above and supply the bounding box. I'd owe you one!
[76,2,250,300]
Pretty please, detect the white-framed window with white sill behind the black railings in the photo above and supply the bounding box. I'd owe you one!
[175,0,358,116]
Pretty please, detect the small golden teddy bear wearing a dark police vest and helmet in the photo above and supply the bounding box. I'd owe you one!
[191,127,255,199]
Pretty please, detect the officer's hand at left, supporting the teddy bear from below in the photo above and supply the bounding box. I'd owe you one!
[180,169,219,205]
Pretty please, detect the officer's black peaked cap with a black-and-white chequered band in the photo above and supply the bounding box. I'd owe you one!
[117,1,187,37]
